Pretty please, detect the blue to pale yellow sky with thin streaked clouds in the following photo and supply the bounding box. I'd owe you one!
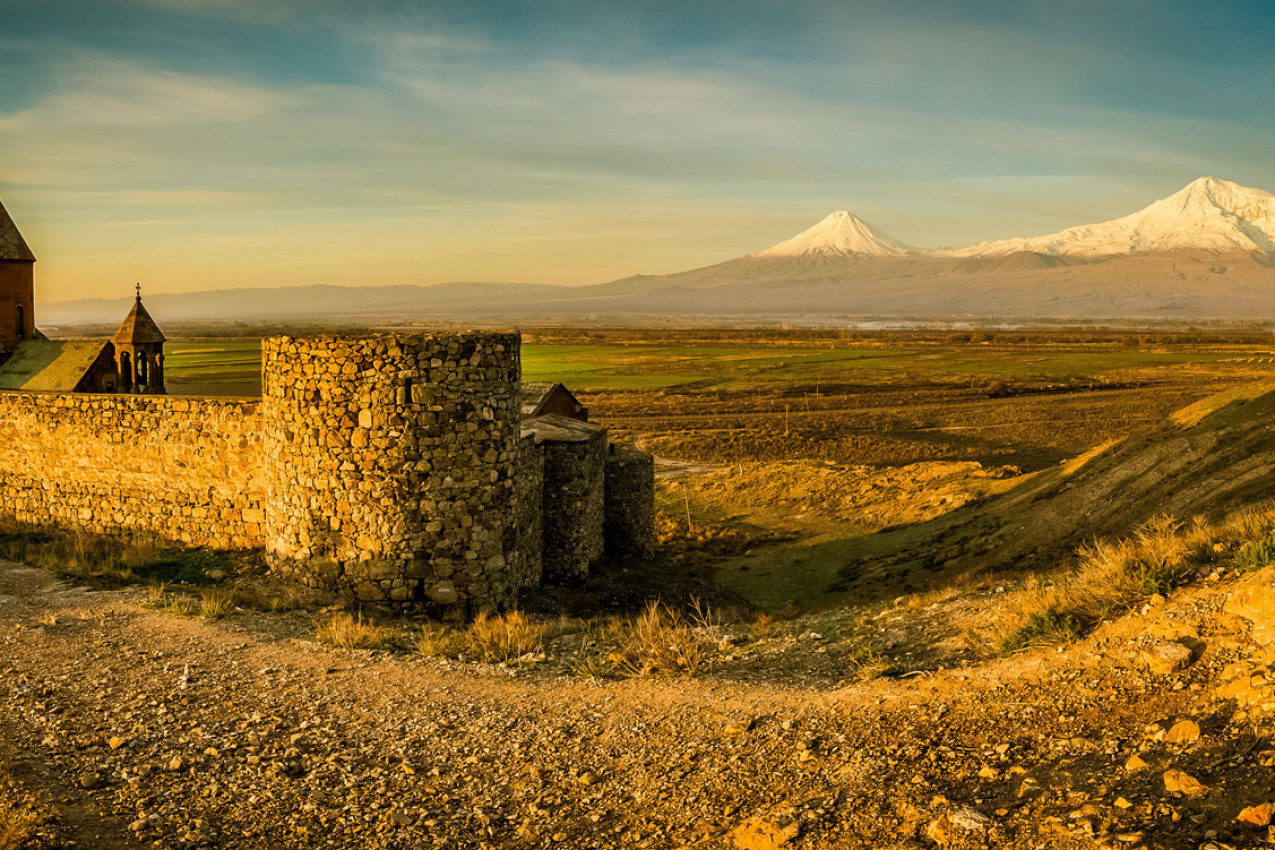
[0,0,1275,302]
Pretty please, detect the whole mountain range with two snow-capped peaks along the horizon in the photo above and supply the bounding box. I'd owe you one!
[40,177,1275,325]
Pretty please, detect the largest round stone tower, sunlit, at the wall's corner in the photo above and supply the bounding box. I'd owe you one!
[263,333,523,610]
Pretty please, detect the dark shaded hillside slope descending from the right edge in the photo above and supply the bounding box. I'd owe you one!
[849,384,1275,598]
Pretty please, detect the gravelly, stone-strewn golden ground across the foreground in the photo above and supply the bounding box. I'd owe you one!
[0,555,1275,850]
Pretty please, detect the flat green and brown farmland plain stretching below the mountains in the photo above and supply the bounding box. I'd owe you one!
[167,330,1275,607]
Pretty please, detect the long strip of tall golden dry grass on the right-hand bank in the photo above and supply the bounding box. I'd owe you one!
[965,505,1275,656]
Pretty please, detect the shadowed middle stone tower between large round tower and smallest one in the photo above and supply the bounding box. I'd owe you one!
[542,428,607,581]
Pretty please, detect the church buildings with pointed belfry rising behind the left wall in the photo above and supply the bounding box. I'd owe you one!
[0,204,164,394]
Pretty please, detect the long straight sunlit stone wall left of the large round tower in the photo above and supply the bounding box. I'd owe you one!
[0,393,265,549]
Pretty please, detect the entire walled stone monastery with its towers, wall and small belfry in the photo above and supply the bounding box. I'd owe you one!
[0,197,654,613]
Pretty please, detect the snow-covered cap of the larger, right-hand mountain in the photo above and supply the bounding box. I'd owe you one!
[935,177,1275,257]
